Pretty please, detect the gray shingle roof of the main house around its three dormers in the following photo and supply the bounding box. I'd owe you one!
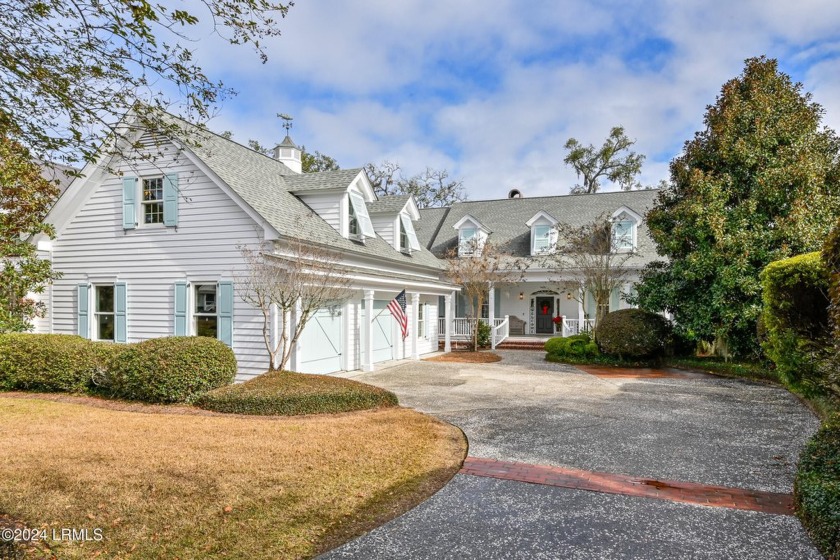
[417,189,659,266]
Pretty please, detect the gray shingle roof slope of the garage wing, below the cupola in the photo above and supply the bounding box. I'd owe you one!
[171,121,443,269]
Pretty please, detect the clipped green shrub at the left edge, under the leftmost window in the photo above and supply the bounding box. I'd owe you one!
[0,333,107,393]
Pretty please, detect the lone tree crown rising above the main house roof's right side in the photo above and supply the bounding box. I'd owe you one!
[563,126,645,194]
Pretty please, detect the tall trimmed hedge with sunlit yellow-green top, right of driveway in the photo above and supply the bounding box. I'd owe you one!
[761,252,830,387]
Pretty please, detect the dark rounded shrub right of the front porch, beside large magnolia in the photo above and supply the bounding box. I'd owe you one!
[595,309,673,359]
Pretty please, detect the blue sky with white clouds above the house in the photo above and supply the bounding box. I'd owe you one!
[196,0,840,199]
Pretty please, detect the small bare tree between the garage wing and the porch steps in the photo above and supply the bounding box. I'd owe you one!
[445,239,523,351]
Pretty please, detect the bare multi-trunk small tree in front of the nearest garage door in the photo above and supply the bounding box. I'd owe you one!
[234,240,352,370]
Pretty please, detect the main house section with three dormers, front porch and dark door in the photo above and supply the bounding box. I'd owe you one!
[417,190,658,342]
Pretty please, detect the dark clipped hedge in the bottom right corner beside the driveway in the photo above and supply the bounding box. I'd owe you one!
[794,415,840,558]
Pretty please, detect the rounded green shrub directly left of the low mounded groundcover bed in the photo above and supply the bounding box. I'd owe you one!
[104,336,236,403]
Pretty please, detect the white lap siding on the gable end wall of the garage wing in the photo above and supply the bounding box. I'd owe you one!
[42,136,268,378]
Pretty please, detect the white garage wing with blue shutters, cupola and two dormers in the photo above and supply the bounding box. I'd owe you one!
[35,115,457,380]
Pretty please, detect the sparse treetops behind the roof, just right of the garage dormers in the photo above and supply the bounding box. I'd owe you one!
[365,161,467,208]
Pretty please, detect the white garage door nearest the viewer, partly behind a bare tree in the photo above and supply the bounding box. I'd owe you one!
[298,309,344,373]
